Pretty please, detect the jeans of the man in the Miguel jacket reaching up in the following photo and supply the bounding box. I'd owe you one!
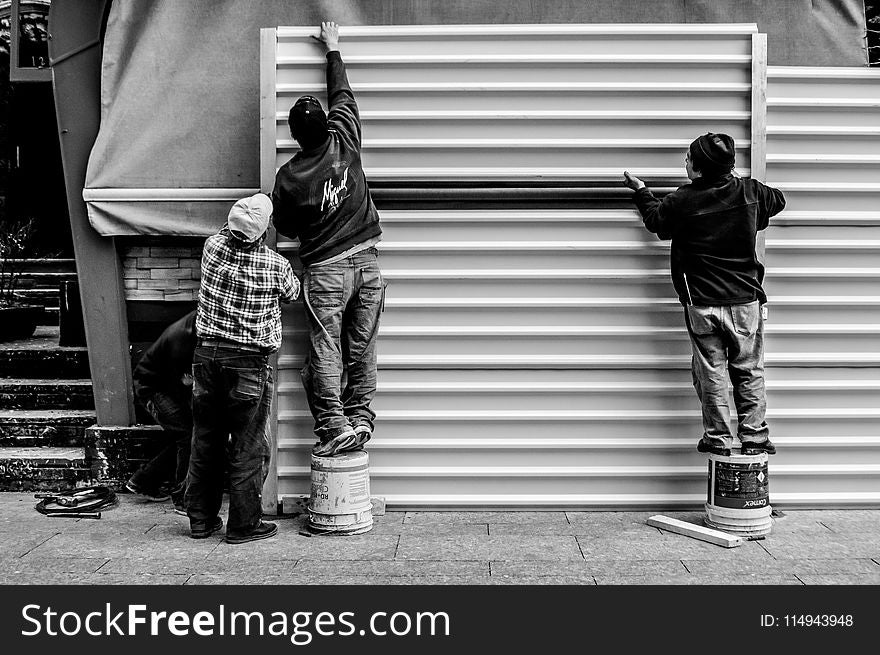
[302,248,385,441]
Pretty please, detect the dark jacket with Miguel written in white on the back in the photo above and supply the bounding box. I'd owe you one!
[272,50,382,266]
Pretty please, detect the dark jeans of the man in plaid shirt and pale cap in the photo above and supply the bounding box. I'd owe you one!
[186,346,274,533]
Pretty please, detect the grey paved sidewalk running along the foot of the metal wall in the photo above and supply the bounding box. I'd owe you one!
[0,493,880,585]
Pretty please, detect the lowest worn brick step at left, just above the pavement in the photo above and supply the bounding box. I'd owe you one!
[0,447,92,492]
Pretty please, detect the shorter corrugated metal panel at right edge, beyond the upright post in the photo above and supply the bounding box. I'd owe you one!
[766,67,880,506]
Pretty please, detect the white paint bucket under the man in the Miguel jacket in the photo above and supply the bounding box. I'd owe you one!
[308,450,373,535]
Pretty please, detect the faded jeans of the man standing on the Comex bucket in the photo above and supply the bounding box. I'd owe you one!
[685,300,770,448]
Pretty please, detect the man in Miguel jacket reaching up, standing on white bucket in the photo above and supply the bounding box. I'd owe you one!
[272,22,384,456]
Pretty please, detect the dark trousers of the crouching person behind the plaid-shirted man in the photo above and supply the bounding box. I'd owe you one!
[131,391,192,501]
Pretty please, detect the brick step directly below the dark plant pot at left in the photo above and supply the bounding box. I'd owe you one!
[0,325,91,380]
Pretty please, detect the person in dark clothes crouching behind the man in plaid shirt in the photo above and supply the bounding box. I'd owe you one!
[125,311,196,514]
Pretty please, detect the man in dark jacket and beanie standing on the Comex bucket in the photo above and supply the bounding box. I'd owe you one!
[624,133,785,455]
